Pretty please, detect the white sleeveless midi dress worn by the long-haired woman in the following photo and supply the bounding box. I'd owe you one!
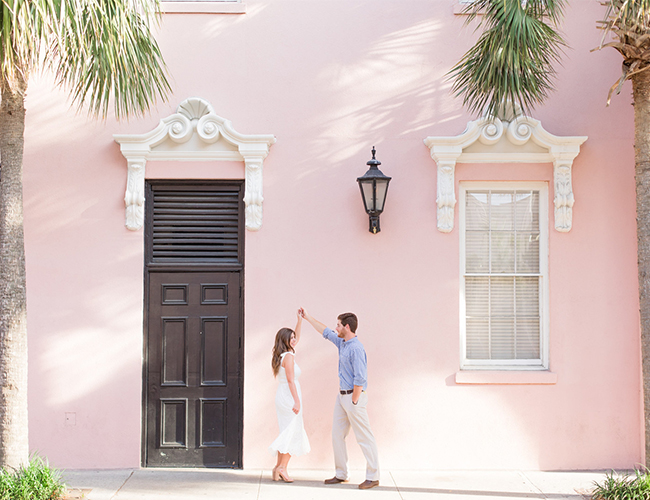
[269,352,311,457]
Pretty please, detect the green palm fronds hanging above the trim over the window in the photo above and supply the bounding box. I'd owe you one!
[449,0,565,116]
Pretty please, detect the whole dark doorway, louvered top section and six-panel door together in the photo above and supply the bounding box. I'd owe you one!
[143,181,244,468]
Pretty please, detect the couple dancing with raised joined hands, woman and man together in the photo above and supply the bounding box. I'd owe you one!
[270,308,379,490]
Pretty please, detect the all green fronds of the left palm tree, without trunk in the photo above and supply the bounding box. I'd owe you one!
[0,0,171,118]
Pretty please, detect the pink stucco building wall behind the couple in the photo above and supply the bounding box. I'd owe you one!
[24,0,644,469]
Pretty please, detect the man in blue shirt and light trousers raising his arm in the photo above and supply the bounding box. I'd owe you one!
[301,309,379,490]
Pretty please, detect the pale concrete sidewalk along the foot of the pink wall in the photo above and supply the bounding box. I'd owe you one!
[63,469,605,500]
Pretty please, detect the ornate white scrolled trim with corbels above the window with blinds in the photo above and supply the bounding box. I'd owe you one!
[424,112,587,233]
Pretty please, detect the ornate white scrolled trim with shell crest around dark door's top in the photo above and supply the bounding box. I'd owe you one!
[113,97,276,231]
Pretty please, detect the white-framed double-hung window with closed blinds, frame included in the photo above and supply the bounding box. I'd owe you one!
[460,182,548,370]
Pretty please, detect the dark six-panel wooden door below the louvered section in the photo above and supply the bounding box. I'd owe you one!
[145,271,242,467]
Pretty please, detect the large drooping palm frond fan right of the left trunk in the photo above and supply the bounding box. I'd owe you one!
[49,0,171,118]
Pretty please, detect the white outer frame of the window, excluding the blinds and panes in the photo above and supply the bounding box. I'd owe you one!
[459,181,550,370]
